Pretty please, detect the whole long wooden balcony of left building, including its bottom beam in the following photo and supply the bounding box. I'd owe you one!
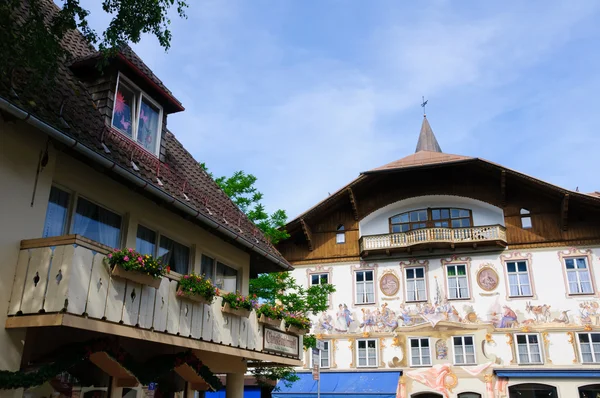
[6,235,302,366]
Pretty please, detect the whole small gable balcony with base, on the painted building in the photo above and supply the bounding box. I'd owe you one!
[360,225,506,257]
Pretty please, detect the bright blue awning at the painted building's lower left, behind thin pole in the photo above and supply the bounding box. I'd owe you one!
[272,372,401,398]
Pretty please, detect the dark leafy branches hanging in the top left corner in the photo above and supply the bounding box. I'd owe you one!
[0,0,187,88]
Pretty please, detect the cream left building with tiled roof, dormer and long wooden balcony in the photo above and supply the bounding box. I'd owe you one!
[0,0,302,398]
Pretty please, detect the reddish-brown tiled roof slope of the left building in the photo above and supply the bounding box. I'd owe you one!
[0,0,289,267]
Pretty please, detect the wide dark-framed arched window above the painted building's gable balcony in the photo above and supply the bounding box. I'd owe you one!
[390,208,473,233]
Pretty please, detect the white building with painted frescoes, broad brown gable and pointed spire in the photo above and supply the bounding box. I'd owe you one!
[276,118,600,398]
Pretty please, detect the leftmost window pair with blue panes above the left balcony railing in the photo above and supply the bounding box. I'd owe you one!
[43,186,122,247]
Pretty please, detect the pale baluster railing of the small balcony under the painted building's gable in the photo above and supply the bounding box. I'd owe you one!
[360,225,506,252]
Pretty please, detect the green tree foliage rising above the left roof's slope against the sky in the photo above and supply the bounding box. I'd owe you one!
[199,163,290,245]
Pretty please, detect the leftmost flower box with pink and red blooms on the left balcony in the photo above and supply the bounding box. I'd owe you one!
[107,248,170,289]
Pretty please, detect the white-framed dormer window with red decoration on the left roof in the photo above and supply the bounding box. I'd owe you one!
[112,75,162,155]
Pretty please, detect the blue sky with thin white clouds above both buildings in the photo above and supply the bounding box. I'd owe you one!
[84,0,600,218]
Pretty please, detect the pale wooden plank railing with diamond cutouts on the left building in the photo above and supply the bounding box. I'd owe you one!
[8,235,302,356]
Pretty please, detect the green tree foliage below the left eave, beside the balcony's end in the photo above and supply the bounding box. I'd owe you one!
[249,272,335,386]
